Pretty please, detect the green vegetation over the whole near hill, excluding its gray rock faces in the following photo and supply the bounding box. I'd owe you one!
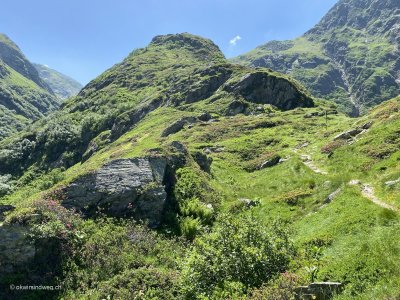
[0,35,400,299]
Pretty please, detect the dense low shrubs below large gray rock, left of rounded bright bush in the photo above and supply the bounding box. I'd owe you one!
[62,219,182,300]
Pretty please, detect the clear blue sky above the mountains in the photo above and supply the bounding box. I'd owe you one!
[0,0,336,84]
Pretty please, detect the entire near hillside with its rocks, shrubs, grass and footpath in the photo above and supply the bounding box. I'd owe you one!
[0,34,400,300]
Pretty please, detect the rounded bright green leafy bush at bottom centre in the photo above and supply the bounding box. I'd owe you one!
[182,216,293,299]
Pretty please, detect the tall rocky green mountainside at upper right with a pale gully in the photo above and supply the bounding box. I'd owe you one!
[233,0,400,116]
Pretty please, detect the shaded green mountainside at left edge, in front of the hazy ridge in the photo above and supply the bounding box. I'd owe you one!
[0,34,59,140]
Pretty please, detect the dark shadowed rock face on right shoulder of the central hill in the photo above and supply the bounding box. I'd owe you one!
[225,71,314,110]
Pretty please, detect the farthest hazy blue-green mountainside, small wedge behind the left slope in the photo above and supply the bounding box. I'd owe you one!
[33,64,82,99]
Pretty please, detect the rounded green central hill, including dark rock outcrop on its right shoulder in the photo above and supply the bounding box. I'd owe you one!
[0,34,314,178]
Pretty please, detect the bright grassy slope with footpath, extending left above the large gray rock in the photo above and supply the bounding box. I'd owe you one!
[2,95,400,299]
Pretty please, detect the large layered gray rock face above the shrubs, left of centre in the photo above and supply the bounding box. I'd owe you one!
[62,157,168,226]
